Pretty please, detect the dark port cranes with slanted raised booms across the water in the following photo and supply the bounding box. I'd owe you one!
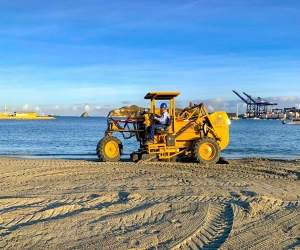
[232,90,277,118]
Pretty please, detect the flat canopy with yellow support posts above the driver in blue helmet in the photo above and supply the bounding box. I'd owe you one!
[144,92,180,116]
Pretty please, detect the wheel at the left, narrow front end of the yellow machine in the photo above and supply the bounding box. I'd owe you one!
[96,136,123,161]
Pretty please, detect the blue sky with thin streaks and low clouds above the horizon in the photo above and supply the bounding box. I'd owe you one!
[0,0,300,116]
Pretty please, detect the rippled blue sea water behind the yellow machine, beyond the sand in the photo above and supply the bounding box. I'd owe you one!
[0,117,300,160]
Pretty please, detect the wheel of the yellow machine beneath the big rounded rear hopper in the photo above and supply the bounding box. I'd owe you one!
[192,137,221,164]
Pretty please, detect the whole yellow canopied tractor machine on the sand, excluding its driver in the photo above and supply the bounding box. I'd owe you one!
[96,92,230,164]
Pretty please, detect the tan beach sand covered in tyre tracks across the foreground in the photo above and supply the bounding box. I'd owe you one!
[0,158,300,250]
